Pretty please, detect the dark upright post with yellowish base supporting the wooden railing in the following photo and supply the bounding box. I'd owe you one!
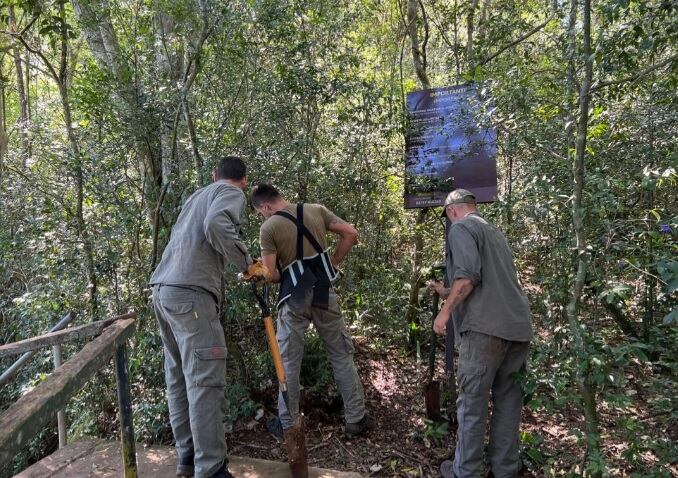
[115,342,137,478]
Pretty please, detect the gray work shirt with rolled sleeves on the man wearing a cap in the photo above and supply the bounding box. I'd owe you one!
[447,213,533,342]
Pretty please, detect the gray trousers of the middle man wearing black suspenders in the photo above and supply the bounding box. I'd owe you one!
[276,290,365,428]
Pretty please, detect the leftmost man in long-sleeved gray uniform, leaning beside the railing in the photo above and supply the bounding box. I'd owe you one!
[149,157,265,478]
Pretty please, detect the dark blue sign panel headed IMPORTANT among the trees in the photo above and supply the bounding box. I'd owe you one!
[405,85,497,208]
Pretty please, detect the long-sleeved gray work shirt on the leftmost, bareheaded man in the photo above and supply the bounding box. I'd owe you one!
[149,180,252,298]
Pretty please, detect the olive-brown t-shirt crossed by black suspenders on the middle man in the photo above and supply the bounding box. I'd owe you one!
[259,204,342,269]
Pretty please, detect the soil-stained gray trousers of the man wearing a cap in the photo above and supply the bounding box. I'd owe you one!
[454,332,529,478]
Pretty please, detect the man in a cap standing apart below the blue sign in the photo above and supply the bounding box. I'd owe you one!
[431,189,532,478]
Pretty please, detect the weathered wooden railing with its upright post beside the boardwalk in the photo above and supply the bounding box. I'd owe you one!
[0,313,137,478]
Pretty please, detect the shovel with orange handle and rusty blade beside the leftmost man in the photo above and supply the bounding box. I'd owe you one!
[252,283,308,478]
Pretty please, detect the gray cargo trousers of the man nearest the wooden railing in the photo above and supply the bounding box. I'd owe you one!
[153,285,228,478]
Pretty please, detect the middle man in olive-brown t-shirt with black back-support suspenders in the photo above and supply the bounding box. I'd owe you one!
[251,184,372,436]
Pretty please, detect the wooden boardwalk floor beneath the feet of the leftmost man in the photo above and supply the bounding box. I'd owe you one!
[15,439,360,478]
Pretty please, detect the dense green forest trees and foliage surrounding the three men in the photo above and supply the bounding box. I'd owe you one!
[0,0,678,477]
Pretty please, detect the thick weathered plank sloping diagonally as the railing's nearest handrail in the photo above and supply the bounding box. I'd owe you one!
[0,318,134,467]
